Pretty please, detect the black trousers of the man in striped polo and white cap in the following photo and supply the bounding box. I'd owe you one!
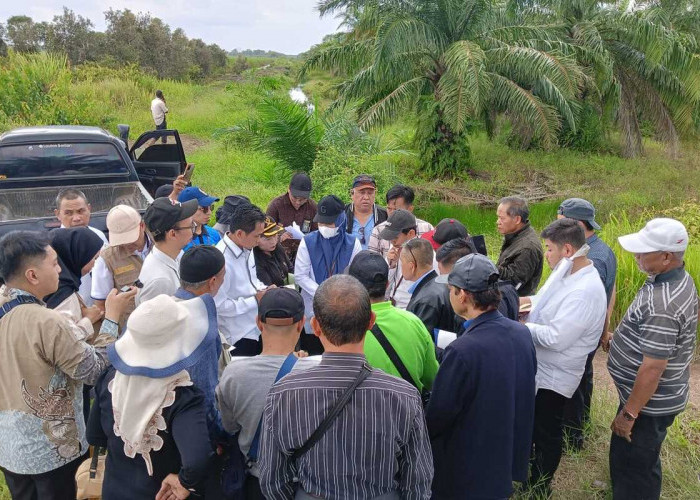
[610,405,676,500]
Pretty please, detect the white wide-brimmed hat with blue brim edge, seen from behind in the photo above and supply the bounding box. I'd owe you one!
[107,295,217,378]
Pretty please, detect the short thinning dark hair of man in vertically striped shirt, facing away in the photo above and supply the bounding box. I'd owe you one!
[314,274,372,346]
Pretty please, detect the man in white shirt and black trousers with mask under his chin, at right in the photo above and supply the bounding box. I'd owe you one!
[521,219,607,498]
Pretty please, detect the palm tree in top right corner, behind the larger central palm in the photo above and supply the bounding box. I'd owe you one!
[517,0,700,158]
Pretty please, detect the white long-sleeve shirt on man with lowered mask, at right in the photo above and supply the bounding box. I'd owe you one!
[525,264,607,398]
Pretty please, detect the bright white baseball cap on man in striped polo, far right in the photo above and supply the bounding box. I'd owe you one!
[617,218,688,253]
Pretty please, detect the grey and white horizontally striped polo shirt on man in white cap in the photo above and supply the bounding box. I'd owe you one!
[608,267,698,416]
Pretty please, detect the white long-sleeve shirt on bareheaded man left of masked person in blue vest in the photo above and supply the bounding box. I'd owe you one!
[214,235,265,345]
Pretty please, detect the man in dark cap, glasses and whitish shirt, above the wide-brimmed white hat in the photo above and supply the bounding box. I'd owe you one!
[136,198,199,306]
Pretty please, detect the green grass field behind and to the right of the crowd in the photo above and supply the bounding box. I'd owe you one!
[0,56,700,500]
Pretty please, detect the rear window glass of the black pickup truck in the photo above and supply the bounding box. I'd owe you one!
[0,143,129,182]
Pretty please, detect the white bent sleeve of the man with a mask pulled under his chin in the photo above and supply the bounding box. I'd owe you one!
[525,293,596,352]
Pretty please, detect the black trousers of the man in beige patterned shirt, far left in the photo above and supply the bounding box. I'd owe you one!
[0,453,88,500]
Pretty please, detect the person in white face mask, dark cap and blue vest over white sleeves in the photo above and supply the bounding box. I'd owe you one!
[294,195,362,355]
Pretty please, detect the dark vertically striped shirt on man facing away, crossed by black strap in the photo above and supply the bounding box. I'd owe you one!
[258,353,433,500]
